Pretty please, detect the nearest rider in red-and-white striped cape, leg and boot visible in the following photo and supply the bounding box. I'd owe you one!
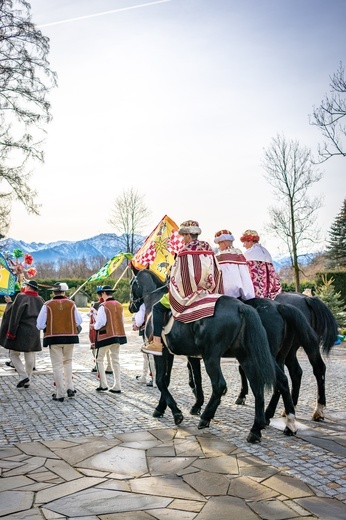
[142,220,223,355]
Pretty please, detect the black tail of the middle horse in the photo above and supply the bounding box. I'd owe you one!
[278,303,319,349]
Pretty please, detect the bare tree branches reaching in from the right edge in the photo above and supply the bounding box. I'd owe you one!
[310,63,346,162]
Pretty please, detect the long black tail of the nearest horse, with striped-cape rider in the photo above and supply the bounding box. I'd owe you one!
[239,305,276,389]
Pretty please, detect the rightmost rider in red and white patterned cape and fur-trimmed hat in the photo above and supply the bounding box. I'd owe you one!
[240,229,282,300]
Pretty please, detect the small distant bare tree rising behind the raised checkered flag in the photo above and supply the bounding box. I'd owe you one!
[109,188,150,254]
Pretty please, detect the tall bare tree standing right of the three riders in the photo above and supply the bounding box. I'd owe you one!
[262,135,322,291]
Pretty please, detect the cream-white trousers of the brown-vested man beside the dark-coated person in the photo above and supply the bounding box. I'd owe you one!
[49,344,74,399]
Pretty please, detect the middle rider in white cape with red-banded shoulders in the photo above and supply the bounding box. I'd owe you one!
[214,229,255,300]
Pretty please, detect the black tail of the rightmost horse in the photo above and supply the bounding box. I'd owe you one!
[306,296,338,355]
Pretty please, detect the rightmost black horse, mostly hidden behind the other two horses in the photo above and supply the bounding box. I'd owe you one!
[236,292,338,421]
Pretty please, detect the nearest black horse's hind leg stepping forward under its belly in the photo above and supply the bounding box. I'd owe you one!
[198,358,227,429]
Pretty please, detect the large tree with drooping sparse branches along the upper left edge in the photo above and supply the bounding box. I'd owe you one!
[0,0,56,236]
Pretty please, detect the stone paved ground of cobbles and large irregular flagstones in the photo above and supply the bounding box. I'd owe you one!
[0,310,346,520]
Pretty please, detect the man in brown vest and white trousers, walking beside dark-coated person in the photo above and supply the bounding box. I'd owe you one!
[36,282,83,402]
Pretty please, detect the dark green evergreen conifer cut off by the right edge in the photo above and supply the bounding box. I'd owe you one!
[327,199,346,269]
